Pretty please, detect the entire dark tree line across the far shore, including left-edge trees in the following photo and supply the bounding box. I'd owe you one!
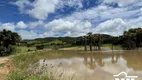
[0,28,142,56]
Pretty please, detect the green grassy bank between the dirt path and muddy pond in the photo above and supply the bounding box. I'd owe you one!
[8,52,49,80]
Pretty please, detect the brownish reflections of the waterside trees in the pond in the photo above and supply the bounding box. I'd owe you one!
[83,53,120,69]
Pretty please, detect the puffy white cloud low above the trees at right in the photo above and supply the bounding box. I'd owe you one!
[94,18,127,36]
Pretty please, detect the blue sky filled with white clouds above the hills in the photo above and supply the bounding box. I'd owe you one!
[0,0,142,39]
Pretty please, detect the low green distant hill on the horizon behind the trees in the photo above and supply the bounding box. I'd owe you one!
[24,34,112,45]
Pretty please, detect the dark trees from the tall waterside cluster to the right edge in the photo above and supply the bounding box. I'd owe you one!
[82,28,142,51]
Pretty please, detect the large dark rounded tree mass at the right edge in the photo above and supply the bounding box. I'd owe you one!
[122,28,142,49]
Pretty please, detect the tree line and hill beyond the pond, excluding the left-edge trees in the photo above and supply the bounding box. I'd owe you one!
[25,28,142,51]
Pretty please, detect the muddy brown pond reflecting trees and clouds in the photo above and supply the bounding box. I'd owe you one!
[40,50,142,80]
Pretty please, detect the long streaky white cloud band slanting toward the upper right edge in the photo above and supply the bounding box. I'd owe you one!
[65,4,142,23]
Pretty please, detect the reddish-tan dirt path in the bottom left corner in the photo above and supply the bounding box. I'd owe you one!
[0,57,12,80]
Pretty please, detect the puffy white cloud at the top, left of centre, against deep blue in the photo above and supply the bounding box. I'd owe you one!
[27,0,59,20]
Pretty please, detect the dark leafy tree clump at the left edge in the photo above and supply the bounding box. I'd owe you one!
[0,29,21,56]
